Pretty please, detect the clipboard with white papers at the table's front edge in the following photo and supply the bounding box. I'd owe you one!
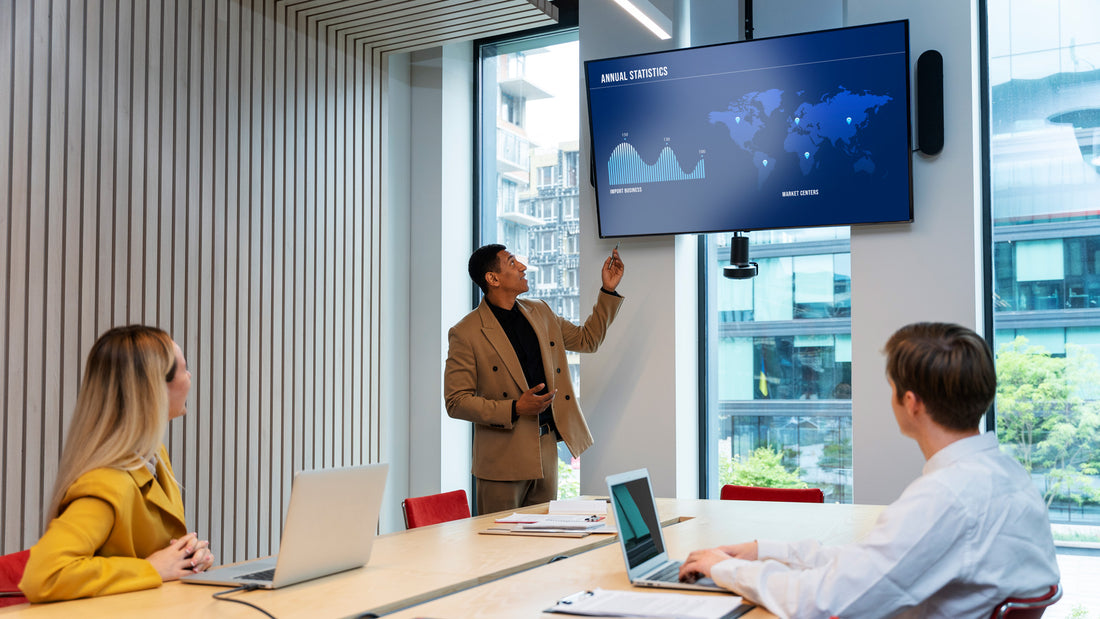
[546,589,754,619]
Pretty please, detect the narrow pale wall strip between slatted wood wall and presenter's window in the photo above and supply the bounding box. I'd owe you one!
[407,43,474,496]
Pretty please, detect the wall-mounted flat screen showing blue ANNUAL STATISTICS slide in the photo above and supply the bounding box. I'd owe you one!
[584,21,913,237]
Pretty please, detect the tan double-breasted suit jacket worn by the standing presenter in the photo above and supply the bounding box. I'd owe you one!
[443,292,623,482]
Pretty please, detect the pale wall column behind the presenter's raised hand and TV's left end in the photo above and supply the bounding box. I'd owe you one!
[579,0,697,496]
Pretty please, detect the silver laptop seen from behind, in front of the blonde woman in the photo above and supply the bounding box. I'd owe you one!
[180,464,389,589]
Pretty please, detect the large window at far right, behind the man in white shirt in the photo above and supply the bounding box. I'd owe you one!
[987,0,1100,542]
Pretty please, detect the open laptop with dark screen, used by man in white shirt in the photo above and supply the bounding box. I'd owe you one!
[607,468,729,593]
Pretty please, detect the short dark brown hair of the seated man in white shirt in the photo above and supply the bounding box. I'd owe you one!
[886,322,997,430]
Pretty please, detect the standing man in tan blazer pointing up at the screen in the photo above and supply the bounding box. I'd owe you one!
[443,244,624,513]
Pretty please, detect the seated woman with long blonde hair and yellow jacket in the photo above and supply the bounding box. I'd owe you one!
[19,325,213,601]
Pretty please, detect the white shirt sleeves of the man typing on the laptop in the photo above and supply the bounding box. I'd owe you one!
[712,479,971,618]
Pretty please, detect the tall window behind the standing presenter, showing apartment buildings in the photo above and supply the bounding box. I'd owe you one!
[477,30,581,497]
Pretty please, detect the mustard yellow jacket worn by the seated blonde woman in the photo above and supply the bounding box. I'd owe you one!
[19,445,187,601]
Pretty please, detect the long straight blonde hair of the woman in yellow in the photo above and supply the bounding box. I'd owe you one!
[45,324,176,524]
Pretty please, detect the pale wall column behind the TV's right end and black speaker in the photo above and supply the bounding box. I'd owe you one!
[847,0,982,504]
